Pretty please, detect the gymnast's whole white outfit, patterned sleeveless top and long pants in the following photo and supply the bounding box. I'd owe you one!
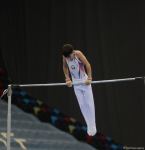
[66,53,97,136]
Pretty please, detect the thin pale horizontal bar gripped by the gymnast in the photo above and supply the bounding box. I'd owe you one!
[12,77,144,87]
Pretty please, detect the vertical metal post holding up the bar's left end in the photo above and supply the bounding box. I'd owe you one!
[7,85,12,150]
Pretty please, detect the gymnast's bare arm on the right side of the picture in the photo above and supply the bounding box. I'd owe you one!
[76,51,92,80]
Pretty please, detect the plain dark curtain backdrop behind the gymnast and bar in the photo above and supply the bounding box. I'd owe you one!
[0,0,145,146]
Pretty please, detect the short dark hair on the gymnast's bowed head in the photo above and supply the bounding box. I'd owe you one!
[62,44,74,57]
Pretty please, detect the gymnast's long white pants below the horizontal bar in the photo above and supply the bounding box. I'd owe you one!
[74,85,96,136]
